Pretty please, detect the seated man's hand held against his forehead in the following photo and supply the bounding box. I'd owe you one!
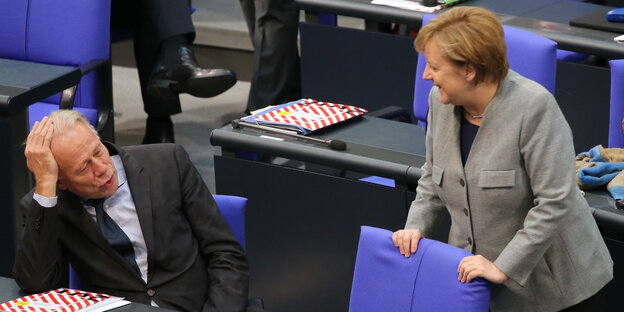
[24,117,58,197]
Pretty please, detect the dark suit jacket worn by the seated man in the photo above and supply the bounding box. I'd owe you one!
[14,143,248,311]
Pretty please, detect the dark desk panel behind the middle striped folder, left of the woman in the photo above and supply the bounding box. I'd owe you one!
[299,23,418,118]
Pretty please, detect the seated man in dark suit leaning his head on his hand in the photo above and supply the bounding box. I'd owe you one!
[14,110,248,311]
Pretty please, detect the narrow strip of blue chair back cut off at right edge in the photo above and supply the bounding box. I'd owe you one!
[609,60,624,147]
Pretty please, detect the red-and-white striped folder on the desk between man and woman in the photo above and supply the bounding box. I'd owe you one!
[243,99,368,135]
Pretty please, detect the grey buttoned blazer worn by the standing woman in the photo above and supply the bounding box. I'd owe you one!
[405,70,613,311]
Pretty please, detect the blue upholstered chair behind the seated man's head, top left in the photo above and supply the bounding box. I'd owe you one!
[0,0,112,139]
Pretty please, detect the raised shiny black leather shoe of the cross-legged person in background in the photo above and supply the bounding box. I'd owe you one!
[146,47,236,99]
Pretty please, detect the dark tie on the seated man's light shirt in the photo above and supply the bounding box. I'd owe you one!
[85,198,141,274]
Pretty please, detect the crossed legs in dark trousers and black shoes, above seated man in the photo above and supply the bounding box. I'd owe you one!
[111,0,236,144]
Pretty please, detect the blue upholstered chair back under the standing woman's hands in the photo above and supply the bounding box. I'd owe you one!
[349,226,490,312]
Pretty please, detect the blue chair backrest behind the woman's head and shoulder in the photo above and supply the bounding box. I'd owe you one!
[414,14,557,127]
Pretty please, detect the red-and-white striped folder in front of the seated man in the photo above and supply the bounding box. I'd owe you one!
[0,288,129,312]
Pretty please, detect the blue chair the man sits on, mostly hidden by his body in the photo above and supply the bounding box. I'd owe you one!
[69,195,247,289]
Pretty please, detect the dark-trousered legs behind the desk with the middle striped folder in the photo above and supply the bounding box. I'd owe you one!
[240,0,301,112]
